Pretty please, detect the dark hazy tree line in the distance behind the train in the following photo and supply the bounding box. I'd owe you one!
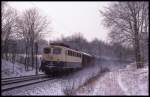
[51,33,134,61]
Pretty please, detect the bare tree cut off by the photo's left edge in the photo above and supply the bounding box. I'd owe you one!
[1,2,18,59]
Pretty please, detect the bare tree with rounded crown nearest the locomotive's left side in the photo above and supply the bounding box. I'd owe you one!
[18,8,49,69]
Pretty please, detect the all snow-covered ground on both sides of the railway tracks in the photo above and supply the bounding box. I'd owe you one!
[2,60,148,95]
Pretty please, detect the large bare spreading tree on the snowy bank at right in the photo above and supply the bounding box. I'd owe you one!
[100,2,149,68]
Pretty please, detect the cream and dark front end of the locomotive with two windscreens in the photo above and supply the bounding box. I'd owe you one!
[40,46,65,72]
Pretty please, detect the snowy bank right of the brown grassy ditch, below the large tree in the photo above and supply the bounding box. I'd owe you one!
[75,62,148,95]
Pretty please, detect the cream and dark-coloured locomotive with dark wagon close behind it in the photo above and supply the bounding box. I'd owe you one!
[40,43,94,74]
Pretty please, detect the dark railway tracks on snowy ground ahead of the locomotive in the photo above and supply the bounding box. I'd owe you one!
[1,74,54,92]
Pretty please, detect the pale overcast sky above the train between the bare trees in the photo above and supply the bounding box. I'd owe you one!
[9,2,109,41]
